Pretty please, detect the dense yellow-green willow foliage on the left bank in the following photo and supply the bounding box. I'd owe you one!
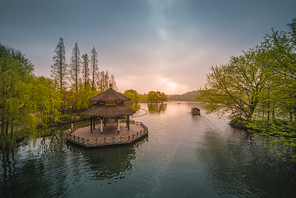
[0,45,62,148]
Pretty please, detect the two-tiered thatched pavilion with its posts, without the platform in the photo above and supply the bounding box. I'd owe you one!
[83,85,136,134]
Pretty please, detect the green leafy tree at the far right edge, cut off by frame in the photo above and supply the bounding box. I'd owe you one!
[249,18,296,161]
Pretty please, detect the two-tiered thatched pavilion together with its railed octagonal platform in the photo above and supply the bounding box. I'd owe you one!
[67,87,148,147]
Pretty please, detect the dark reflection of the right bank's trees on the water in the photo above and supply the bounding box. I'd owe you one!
[196,131,295,197]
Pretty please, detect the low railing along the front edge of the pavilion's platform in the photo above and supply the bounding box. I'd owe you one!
[66,122,148,147]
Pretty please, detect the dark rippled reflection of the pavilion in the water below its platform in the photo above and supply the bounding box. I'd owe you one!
[68,137,148,180]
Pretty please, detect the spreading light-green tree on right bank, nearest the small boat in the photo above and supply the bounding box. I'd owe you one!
[196,50,269,119]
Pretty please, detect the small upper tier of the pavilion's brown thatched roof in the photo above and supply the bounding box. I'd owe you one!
[89,88,131,102]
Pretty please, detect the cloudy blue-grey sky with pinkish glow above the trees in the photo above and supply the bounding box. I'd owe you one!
[0,0,296,94]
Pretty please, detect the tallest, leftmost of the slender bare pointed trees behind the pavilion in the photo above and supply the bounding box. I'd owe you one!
[51,37,67,93]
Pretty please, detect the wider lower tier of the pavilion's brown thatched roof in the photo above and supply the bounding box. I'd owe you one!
[83,103,136,118]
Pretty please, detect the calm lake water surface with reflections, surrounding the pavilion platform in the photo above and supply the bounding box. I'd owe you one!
[0,102,296,198]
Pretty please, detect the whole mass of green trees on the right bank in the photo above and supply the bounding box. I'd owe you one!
[196,18,296,161]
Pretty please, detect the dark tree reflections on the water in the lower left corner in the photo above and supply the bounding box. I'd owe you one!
[0,129,68,197]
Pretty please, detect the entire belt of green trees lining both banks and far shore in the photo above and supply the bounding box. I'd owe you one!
[0,18,296,162]
